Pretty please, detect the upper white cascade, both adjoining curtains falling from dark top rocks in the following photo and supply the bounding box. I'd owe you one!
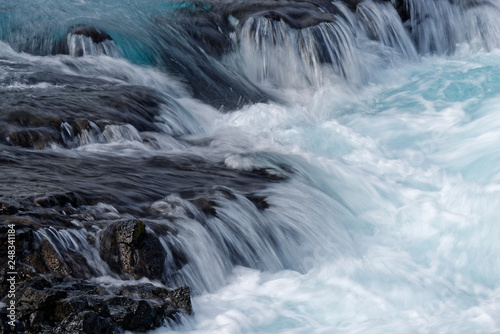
[234,1,418,87]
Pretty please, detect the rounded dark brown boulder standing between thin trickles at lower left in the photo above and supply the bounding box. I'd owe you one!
[100,220,166,279]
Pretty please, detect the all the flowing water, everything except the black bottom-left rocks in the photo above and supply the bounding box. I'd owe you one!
[0,0,500,333]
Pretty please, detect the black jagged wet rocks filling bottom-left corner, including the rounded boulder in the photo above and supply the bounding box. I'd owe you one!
[0,221,192,333]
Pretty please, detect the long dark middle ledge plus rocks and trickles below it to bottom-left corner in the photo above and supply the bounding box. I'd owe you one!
[0,149,292,333]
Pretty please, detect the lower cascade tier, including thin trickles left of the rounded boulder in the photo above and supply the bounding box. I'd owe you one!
[24,175,355,294]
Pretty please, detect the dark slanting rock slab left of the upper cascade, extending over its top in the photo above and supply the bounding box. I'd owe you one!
[151,0,403,111]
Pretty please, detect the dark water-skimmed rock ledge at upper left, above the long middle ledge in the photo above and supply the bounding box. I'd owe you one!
[0,65,167,149]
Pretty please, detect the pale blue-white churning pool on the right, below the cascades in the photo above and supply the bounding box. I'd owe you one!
[148,51,500,333]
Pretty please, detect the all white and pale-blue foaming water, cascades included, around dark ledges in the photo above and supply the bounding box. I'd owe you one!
[0,0,500,334]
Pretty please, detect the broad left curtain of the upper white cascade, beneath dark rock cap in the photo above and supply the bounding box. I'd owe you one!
[239,12,366,87]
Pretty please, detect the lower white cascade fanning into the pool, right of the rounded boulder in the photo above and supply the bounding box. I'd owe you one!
[143,176,354,293]
